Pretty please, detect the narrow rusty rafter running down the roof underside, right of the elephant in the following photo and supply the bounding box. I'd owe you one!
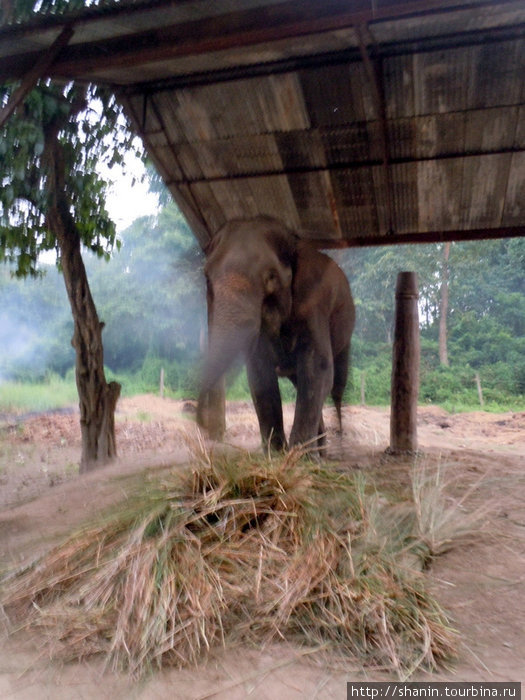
[354,24,395,235]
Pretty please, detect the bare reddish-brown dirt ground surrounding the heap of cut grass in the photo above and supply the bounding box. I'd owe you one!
[0,395,525,700]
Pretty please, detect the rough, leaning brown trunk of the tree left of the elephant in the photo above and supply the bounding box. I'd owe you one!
[48,200,120,473]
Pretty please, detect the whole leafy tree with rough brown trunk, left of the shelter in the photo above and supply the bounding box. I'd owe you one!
[0,0,139,471]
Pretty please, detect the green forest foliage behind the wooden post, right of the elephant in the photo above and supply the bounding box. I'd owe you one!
[338,238,525,408]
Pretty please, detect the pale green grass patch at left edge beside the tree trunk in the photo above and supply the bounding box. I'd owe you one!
[0,376,78,413]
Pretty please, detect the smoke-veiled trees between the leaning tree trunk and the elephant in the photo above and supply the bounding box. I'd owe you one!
[85,203,205,379]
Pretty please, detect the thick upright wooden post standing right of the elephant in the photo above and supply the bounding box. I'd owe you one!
[389,272,419,454]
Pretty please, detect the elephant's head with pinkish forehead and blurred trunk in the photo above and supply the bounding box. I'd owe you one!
[201,217,297,404]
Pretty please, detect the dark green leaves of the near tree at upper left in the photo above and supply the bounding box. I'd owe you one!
[0,81,137,277]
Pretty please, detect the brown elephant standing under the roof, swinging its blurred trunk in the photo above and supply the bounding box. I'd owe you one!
[197,216,355,450]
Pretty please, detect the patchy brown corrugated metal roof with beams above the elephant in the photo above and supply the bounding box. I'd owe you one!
[0,0,525,246]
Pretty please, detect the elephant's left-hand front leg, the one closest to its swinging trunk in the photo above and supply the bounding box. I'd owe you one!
[246,337,286,450]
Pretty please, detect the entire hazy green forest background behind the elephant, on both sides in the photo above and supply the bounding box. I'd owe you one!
[0,189,525,412]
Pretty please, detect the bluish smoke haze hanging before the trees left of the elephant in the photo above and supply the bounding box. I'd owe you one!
[0,202,206,388]
